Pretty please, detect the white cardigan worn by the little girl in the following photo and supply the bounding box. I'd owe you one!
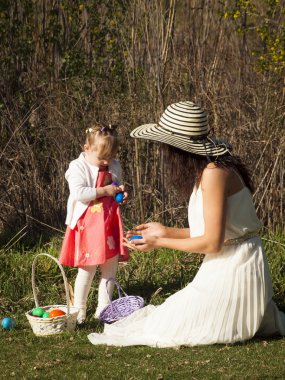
[65,153,122,229]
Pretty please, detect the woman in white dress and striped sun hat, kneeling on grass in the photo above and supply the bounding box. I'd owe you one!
[89,101,285,347]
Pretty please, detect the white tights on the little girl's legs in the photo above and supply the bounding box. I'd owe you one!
[74,255,118,323]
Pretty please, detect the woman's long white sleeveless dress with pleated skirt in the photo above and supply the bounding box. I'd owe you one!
[88,187,285,347]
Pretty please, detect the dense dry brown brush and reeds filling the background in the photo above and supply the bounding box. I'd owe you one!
[0,0,285,248]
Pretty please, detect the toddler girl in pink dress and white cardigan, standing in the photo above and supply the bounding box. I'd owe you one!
[59,125,128,323]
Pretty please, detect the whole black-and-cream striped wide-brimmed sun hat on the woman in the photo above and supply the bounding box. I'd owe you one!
[131,101,230,156]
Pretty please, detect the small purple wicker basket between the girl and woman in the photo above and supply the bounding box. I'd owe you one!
[99,278,144,323]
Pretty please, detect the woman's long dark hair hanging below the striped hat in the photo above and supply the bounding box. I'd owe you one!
[162,144,253,200]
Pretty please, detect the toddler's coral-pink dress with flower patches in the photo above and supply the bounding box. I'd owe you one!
[59,171,129,267]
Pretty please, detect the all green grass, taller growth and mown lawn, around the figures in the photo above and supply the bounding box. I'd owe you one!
[0,233,285,380]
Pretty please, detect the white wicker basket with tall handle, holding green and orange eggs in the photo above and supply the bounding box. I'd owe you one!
[25,253,79,336]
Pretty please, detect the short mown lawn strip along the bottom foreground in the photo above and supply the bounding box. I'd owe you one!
[0,324,285,380]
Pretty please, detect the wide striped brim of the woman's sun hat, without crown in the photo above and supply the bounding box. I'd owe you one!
[130,124,229,156]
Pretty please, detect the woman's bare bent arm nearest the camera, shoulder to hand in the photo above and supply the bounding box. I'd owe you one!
[132,165,229,253]
